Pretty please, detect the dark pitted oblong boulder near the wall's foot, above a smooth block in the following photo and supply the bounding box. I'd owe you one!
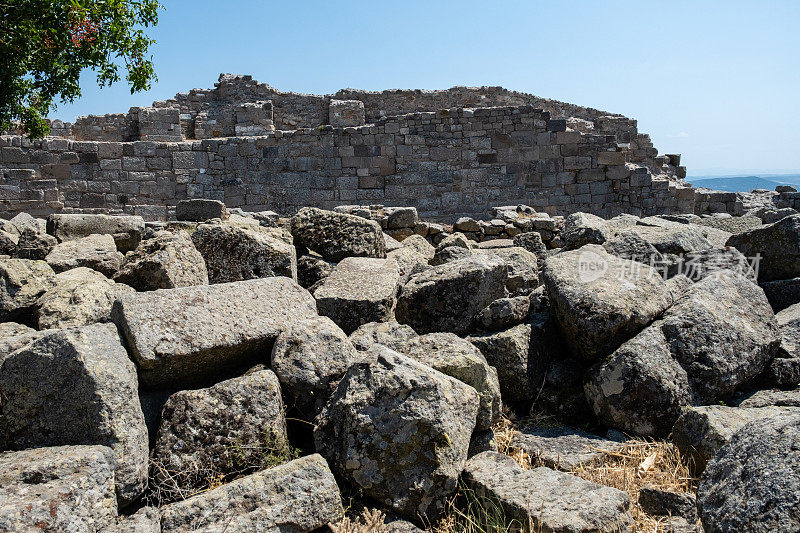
[291,207,386,262]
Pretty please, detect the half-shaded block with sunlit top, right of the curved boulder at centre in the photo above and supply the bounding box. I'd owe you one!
[467,324,534,403]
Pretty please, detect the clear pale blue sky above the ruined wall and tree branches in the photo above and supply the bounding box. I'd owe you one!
[53,0,800,175]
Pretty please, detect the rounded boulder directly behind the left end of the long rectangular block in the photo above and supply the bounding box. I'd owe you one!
[115,231,208,291]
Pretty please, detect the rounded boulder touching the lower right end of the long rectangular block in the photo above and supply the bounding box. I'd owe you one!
[271,316,363,420]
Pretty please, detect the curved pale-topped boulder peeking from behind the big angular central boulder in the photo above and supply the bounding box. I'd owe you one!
[404,333,502,431]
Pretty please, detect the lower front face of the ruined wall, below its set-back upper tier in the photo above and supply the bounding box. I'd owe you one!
[0,106,694,222]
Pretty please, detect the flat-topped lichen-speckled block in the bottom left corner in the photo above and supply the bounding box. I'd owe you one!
[0,446,117,532]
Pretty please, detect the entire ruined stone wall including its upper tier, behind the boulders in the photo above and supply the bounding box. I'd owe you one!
[0,74,756,222]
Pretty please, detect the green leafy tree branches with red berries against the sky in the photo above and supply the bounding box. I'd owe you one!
[0,0,160,137]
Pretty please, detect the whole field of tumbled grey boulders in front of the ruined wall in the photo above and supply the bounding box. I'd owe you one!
[0,200,800,533]
